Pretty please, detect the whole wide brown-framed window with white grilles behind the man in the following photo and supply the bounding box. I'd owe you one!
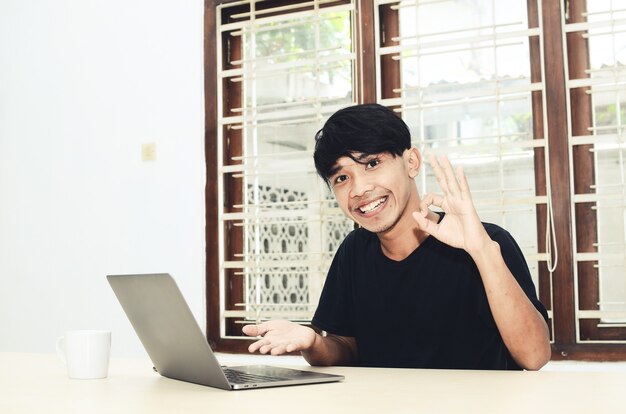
[205,0,626,359]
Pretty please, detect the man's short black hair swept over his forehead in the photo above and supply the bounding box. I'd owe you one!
[313,104,411,184]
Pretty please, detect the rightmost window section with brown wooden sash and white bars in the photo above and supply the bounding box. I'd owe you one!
[564,0,626,350]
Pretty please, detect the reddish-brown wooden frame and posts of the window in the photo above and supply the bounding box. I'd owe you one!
[204,0,626,361]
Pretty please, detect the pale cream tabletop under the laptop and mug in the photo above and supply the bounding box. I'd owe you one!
[0,353,626,414]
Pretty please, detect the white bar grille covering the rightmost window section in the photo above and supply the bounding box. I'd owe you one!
[564,0,626,336]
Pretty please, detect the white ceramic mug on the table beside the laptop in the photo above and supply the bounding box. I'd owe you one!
[56,330,111,379]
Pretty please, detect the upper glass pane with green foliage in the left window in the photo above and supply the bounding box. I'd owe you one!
[243,12,352,108]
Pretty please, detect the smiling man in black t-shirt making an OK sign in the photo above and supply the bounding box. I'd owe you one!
[243,104,550,370]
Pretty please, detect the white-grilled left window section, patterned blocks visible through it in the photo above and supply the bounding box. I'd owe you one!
[217,0,356,337]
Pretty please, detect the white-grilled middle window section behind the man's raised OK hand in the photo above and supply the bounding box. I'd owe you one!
[375,0,554,316]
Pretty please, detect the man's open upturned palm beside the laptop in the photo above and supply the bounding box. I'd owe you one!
[243,320,317,355]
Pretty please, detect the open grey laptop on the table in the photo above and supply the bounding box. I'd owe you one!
[107,273,345,390]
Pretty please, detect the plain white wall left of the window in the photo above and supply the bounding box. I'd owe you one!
[0,0,205,356]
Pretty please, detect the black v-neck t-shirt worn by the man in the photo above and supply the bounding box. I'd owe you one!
[313,223,548,369]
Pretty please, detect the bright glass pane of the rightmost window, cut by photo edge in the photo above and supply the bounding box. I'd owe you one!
[570,0,626,328]
